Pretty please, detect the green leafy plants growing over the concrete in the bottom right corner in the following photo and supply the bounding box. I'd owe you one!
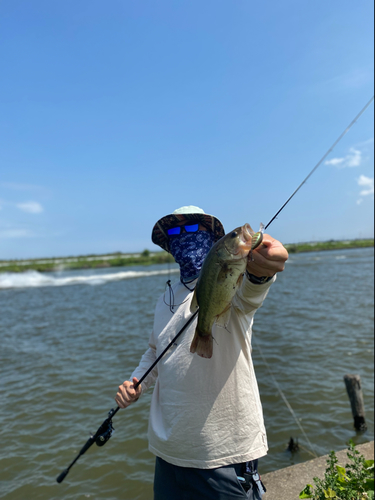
[299,441,374,500]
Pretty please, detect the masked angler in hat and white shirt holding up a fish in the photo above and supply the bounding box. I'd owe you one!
[115,206,288,500]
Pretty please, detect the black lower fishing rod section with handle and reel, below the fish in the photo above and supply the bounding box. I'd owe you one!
[56,309,199,483]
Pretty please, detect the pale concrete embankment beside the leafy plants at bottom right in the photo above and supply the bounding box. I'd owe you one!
[262,441,374,500]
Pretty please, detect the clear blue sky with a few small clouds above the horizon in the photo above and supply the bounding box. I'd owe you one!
[0,0,374,259]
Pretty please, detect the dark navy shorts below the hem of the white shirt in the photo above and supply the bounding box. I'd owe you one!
[154,457,263,500]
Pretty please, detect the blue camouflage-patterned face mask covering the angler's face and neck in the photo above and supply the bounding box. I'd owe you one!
[169,231,214,282]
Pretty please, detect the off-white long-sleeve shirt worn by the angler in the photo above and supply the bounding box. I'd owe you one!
[132,277,274,469]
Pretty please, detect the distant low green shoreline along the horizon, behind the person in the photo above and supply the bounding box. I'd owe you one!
[0,238,374,273]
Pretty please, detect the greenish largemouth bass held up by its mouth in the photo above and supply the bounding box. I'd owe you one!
[190,224,263,358]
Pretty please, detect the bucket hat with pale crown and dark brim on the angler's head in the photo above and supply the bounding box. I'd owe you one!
[151,205,225,252]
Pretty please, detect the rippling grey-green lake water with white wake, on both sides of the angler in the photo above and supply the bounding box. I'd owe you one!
[0,248,374,500]
